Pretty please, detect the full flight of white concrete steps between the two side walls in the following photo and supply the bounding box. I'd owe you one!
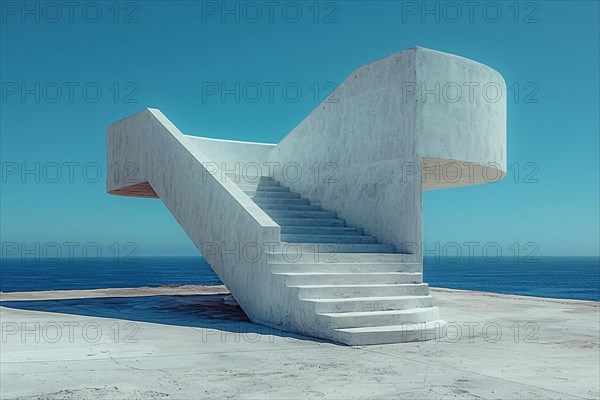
[229,176,445,345]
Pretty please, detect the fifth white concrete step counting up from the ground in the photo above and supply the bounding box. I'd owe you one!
[273,272,423,286]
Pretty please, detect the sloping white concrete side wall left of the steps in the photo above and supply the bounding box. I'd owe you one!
[107,109,290,328]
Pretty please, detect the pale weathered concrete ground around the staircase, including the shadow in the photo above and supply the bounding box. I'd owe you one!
[0,287,600,399]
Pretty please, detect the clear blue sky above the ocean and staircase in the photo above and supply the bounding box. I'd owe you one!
[0,1,600,255]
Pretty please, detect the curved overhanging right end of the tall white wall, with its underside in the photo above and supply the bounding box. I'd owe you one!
[418,48,507,190]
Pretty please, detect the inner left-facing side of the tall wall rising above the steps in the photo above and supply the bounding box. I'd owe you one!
[269,50,422,251]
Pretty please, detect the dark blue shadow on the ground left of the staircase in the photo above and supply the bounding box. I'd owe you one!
[0,294,314,340]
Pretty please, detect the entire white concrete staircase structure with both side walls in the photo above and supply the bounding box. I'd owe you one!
[107,48,506,344]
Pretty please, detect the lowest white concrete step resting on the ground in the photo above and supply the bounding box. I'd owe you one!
[330,319,446,346]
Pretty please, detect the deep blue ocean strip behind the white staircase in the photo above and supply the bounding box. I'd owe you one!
[0,257,600,301]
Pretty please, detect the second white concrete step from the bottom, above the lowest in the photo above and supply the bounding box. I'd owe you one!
[317,307,440,329]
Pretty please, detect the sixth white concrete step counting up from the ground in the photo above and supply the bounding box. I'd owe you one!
[271,260,421,273]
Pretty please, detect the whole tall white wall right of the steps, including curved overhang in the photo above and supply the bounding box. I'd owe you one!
[269,47,506,254]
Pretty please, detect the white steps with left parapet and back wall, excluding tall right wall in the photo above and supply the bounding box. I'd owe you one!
[107,109,444,345]
